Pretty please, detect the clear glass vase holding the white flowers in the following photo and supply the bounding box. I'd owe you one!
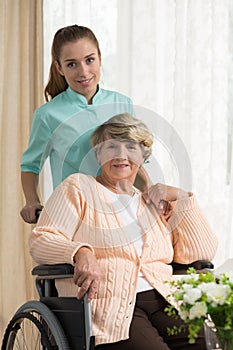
[204,318,233,350]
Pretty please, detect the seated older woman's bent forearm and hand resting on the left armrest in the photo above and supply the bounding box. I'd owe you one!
[29,224,101,301]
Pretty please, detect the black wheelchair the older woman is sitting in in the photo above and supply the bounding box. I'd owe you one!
[1,260,214,350]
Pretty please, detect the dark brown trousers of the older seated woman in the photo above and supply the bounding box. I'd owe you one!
[96,290,206,350]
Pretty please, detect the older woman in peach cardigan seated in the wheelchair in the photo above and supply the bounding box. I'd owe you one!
[30,114,217,350]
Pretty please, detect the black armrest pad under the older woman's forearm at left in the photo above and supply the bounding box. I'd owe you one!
[32,264,74,276]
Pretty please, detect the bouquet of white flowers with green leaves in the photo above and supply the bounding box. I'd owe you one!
[165,268,233,349]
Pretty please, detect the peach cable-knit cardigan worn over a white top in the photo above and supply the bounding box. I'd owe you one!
[29,174,217,344]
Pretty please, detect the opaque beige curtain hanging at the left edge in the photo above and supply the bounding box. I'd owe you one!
[0,0,43,339]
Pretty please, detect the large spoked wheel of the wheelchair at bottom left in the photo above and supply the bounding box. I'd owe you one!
[1,301,70,350]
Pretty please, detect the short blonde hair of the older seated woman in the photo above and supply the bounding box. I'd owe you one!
[90,113,153,160]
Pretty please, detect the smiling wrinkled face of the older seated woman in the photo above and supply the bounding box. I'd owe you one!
[97,139,144,183]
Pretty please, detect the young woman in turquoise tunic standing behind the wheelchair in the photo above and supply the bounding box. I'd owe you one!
[21,25,133,223]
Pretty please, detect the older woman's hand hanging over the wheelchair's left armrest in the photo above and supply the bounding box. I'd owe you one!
[74,247,102,301]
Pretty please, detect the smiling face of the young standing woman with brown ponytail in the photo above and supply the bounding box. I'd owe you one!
[56,38,101,103]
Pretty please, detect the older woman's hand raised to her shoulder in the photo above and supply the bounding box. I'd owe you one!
[143,183,189,215]
